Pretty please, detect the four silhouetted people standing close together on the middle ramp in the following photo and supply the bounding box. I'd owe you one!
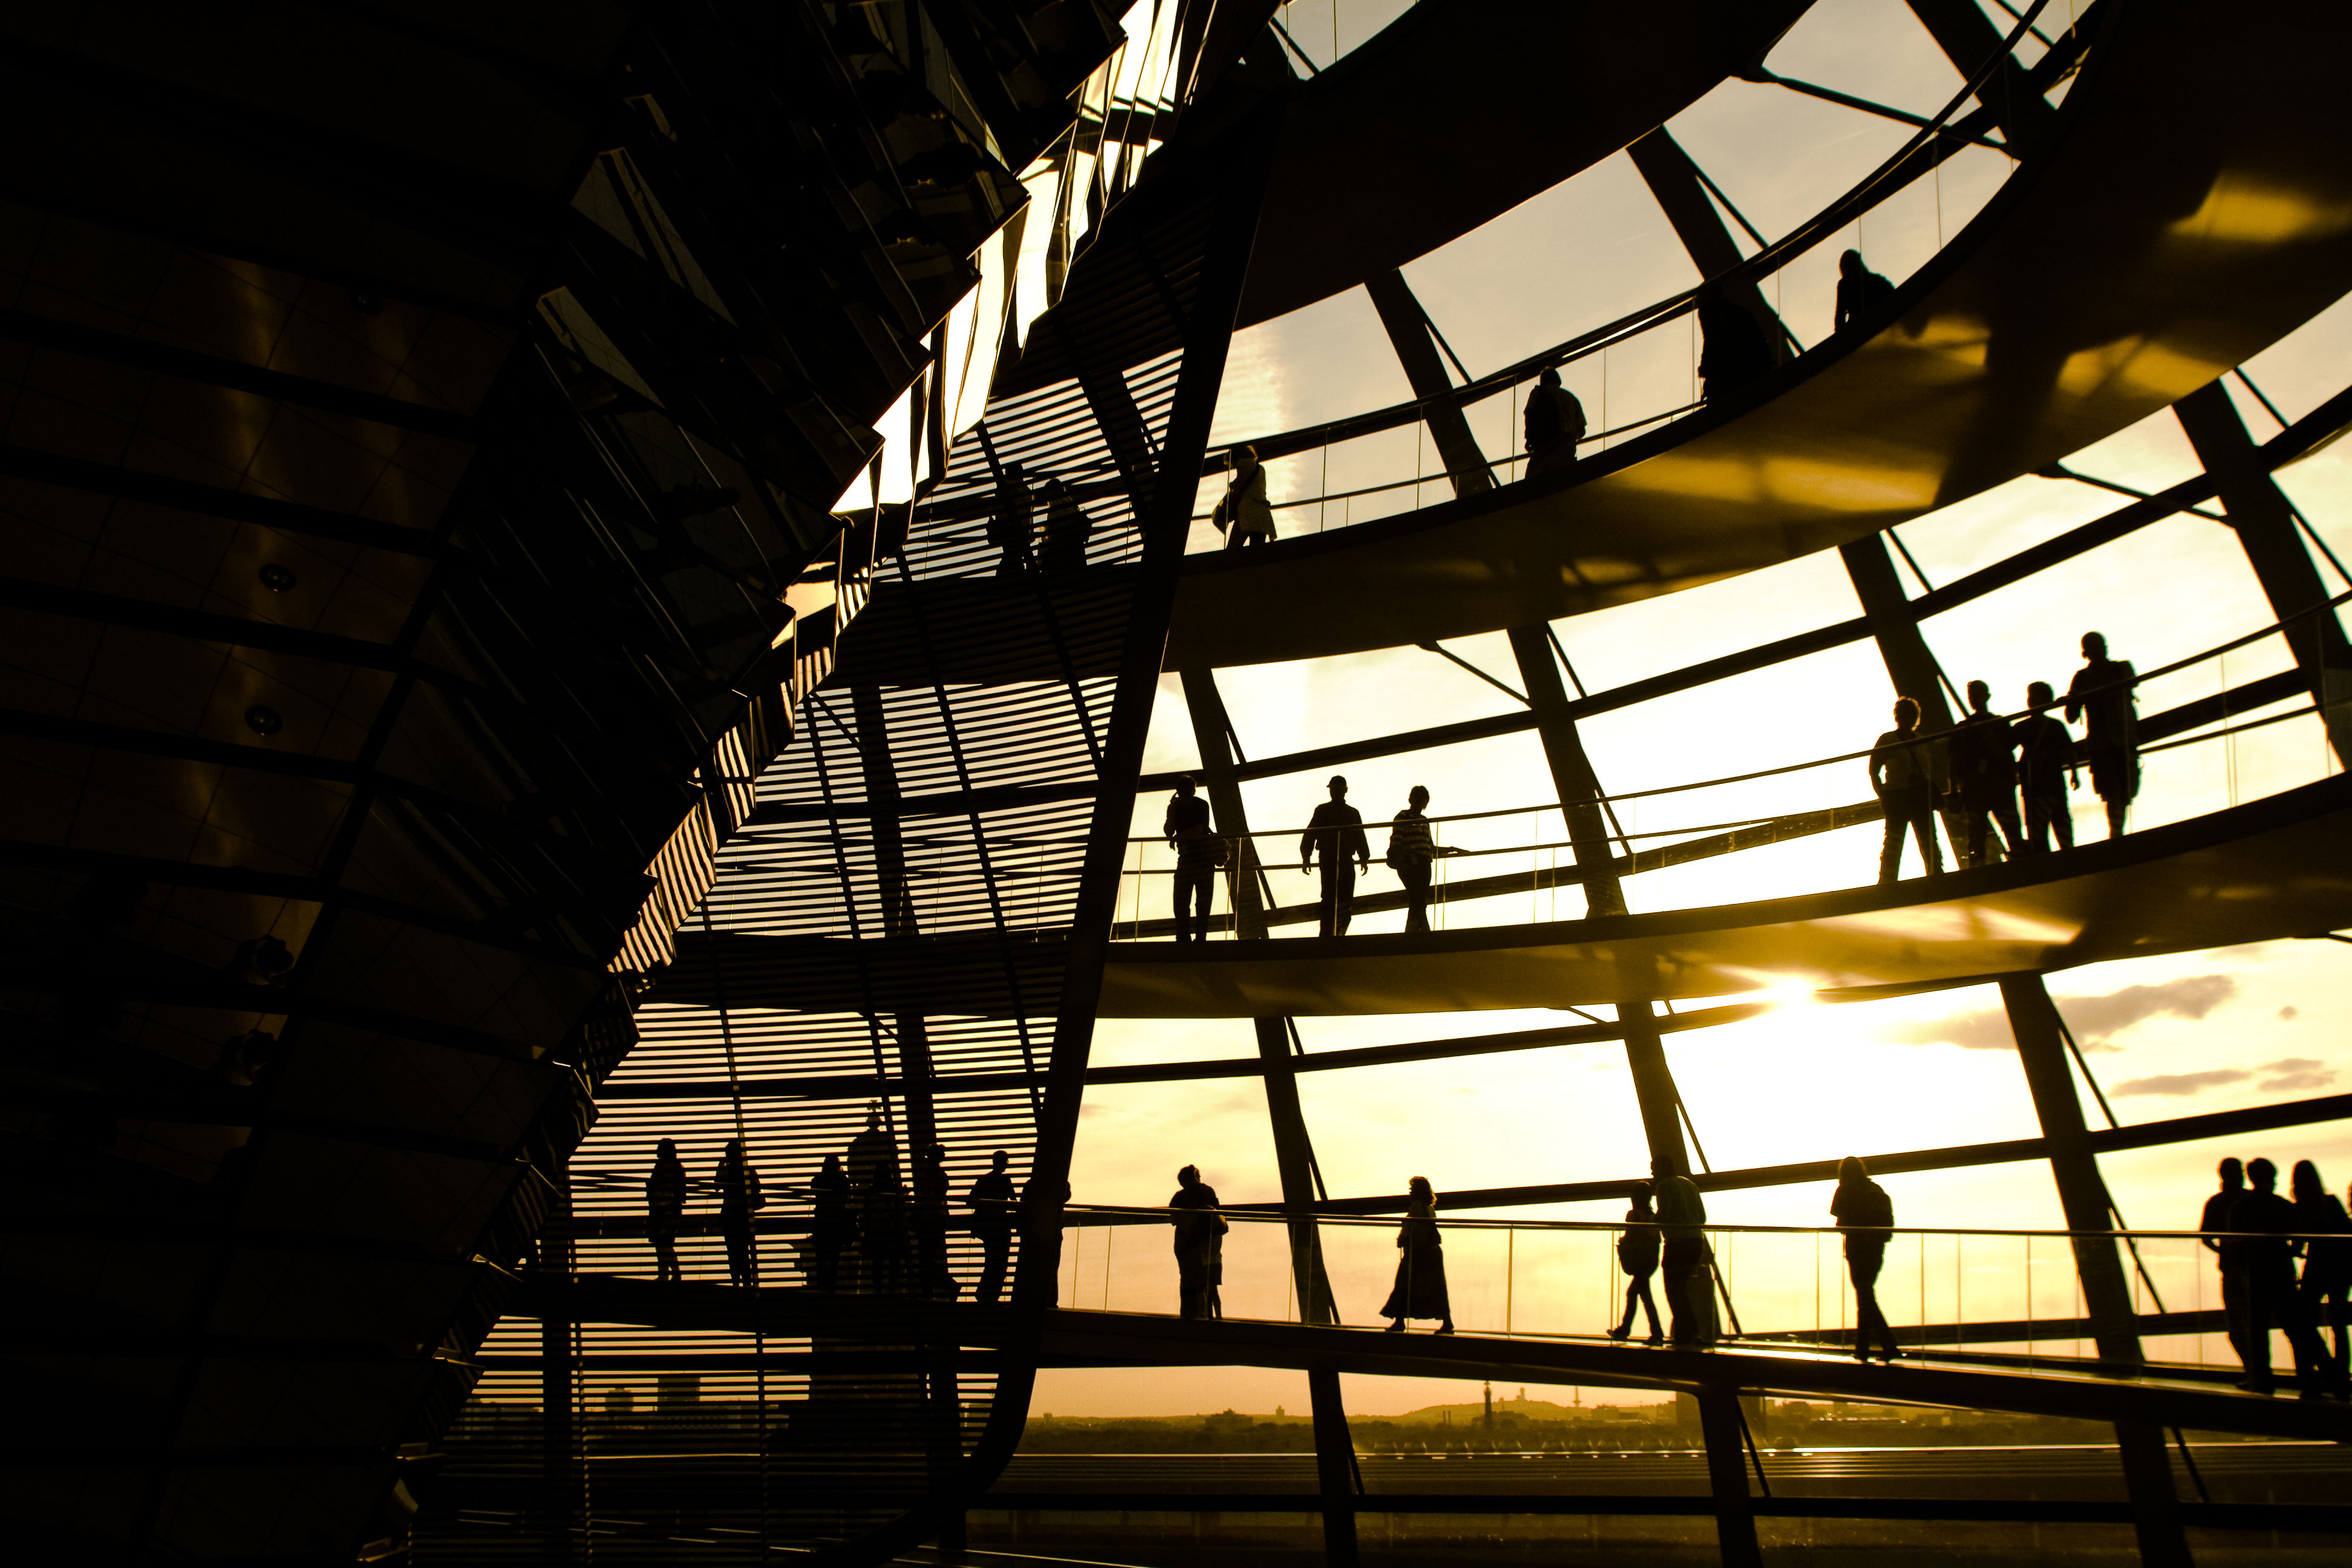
[1870,632,2140,881]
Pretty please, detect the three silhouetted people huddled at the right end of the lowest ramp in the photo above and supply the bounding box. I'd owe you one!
[2197,1159,2352,1399]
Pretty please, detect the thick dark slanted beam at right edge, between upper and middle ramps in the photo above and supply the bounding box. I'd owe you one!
[2174,381,2352,762]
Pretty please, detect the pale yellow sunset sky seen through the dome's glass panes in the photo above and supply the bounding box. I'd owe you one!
[1035,0,2352,1415]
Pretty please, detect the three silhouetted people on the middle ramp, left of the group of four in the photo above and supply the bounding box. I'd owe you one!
[1160,774,1463,942]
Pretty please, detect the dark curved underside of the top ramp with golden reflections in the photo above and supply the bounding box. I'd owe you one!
[1166,0,2352,668]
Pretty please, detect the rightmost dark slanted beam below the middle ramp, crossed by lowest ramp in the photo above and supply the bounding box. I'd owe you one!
[2002,976,2190,1568]
